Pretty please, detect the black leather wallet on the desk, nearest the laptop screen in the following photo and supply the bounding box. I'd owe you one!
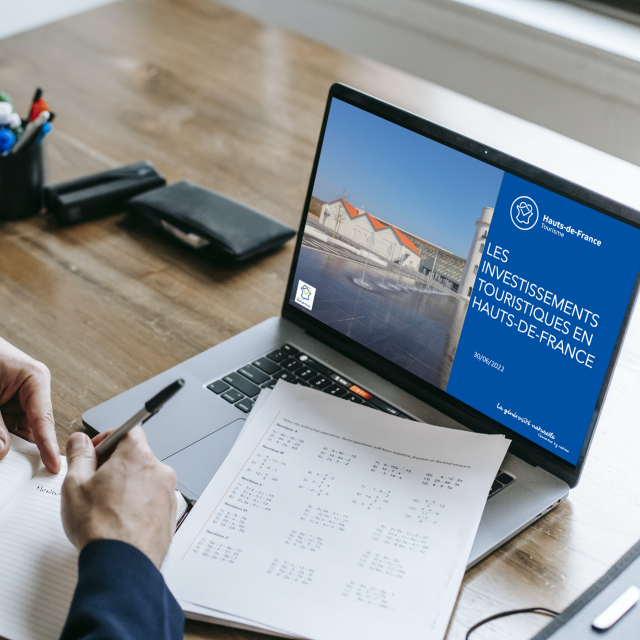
[127,180,296,263]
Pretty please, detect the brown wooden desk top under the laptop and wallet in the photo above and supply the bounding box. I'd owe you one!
[0,0,640,640]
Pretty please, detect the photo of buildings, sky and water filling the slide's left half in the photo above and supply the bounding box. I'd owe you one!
[290,99,504,390]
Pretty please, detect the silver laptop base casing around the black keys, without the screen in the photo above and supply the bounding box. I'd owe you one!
[82,317,569,566]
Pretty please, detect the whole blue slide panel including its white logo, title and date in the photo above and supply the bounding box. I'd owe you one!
[446,174,640,464]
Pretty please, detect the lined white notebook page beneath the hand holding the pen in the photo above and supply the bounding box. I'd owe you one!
[0,456,78,640]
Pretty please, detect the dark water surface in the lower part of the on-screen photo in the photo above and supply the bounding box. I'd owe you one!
[294,247,468,390]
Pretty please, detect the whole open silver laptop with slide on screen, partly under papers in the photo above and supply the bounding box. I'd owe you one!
[83,84,640,565]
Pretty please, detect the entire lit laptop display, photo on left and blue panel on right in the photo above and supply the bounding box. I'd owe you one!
[289,98,640,465]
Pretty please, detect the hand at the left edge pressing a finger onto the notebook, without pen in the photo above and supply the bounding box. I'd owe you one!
[0,338,60,473]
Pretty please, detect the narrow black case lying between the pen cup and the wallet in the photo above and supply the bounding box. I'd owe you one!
[45,160,167,225]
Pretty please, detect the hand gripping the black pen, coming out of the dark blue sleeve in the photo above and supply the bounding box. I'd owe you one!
[62,427,176,568]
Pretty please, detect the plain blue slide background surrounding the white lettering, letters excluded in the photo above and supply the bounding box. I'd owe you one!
[447,174,640,464]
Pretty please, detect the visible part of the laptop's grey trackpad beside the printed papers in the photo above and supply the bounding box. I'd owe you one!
[163,418,245,500]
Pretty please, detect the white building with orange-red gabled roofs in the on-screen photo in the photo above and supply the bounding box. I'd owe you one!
[320,198,420,271]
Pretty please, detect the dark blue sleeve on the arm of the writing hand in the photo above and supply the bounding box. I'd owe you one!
[60,540,184,640]
